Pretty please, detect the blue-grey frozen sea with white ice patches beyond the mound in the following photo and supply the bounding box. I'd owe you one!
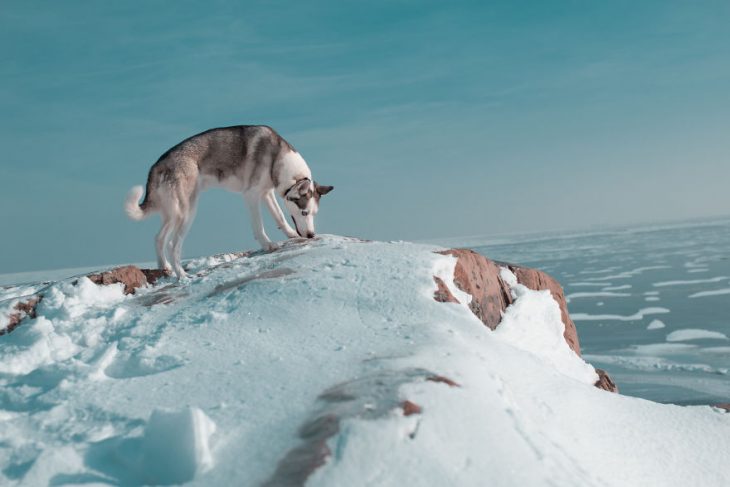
[460,219,730,404]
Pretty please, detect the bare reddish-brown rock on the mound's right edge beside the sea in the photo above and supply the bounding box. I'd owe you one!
[434,249,618,392]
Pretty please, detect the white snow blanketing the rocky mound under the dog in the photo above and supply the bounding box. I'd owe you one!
[0,236,730,487]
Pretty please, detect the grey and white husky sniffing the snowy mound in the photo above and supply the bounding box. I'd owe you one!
[124,125,333,278]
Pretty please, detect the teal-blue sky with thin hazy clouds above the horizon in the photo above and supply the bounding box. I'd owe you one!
[0,0,730,273]
